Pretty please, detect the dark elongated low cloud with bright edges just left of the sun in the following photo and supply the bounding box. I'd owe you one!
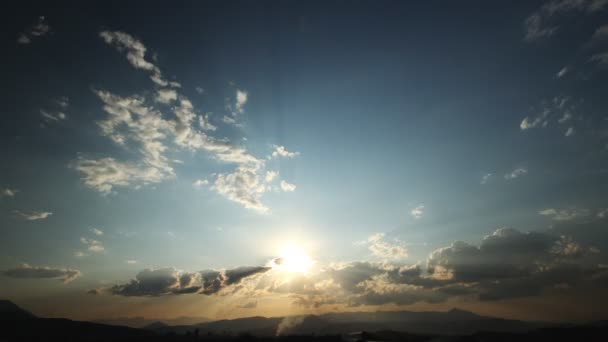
[108,267,270,296]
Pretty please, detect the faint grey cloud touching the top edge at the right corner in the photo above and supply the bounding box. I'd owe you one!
[524,0,608,42]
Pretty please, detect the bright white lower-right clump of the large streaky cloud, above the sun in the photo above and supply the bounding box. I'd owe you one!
[213,166,268,212]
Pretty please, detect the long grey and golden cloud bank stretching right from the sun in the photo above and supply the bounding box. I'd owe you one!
[252,228,602,307]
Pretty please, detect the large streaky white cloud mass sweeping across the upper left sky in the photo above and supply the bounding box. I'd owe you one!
[70,31,297,212]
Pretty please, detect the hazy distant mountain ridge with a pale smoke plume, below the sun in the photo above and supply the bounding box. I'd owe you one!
[154,309,551,336]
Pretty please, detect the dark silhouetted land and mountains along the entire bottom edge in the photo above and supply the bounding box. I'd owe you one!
[0,301,608,342]
